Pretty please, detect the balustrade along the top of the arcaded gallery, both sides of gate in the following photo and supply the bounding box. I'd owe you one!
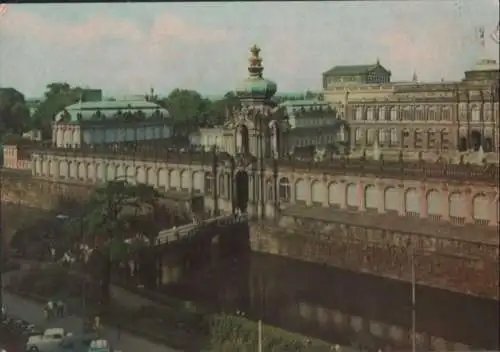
[28,144,500,184]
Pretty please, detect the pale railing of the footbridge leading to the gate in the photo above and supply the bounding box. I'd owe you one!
[156,214,249,246]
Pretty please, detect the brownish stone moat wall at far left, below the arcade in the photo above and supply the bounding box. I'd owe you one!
[0,169,93,210]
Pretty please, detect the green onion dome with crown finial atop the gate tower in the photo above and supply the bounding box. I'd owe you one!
[235,45,278,99]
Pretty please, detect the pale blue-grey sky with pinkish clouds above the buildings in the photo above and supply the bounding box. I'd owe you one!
[0,0,499,97]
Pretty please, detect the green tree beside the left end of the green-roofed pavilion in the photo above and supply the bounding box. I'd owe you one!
[33,83,83,138]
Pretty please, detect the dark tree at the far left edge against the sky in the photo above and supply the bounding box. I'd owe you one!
[0,88,30,135]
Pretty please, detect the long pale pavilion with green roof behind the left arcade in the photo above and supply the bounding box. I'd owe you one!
[52,100,172,148]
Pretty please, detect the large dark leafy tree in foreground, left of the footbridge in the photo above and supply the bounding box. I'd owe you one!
[78,181,160,304]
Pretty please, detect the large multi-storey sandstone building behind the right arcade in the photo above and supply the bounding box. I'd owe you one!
[323,60,500,161]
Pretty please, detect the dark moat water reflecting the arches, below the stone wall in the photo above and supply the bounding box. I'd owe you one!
[2,206,500,350]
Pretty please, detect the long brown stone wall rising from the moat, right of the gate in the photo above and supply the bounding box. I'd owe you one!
[250,221,499,299]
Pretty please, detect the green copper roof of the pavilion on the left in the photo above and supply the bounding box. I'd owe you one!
[55,100,169,122]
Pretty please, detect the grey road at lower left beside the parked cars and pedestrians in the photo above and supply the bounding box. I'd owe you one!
[3,280,178,352]
